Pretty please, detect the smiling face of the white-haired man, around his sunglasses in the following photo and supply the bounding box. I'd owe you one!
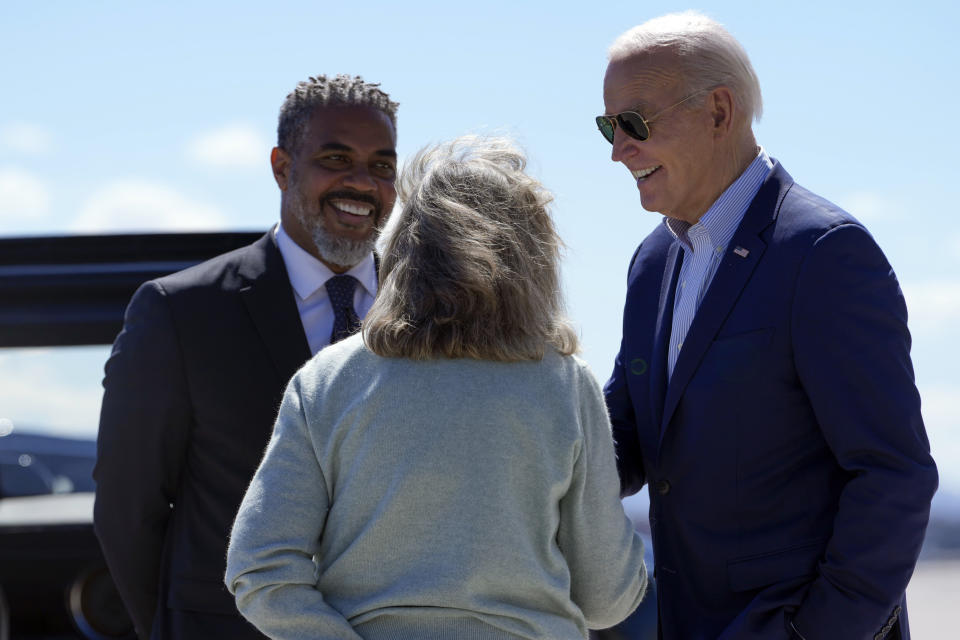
[603,52,739,223]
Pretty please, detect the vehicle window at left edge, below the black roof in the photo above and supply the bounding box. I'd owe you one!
[0,345,110,497]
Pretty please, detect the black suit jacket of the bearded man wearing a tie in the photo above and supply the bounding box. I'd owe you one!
[94,233,310,638]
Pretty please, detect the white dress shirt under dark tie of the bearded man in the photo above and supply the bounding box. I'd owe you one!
[274,224,377,354]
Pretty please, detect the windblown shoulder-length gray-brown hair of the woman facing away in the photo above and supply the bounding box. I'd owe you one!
[363,136,578,361]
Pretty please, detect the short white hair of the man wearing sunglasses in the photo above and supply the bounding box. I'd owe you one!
[607,11,763,125]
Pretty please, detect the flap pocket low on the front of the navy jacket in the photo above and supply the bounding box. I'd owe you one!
[727,538,827,591]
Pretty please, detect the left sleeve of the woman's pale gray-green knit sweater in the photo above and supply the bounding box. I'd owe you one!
[225,372,360,640]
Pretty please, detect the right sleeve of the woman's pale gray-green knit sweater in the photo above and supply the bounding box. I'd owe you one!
[557,365,647,628]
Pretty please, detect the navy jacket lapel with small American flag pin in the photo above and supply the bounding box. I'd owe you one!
[660,163,793,438]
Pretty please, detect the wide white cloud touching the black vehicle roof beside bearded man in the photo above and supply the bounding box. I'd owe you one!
[72,180,227,232]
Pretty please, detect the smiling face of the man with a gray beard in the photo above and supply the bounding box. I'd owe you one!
[270,106,397,273]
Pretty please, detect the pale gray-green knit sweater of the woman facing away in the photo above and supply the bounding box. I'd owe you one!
[226,335,646,640]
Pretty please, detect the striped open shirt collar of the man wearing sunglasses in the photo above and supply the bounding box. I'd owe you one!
[663,147,773,248]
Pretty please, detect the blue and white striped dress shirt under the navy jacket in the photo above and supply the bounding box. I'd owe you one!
[663,148,773,376]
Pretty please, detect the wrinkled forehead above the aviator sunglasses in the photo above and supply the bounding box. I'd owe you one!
[603,51,683,113]
